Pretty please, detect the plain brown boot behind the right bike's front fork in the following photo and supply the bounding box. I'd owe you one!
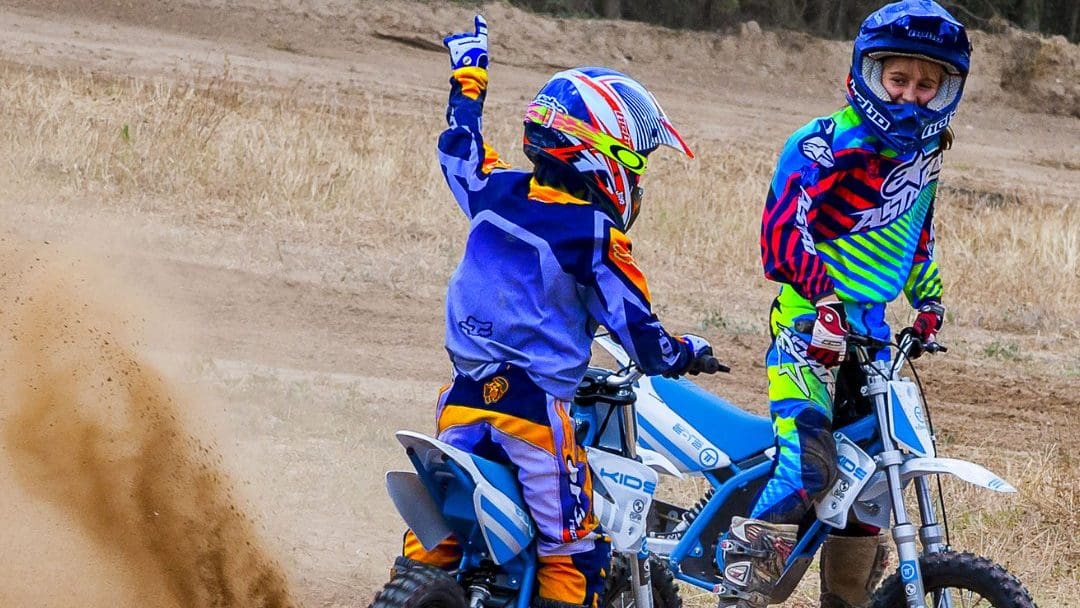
[821,535,889,608]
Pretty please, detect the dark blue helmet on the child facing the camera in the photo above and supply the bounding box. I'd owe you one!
[848,0,971,153]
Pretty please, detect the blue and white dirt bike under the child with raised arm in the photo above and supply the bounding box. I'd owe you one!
[372,364,718,608]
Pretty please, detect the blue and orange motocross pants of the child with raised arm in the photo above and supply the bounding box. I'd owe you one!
[404,365,610,606]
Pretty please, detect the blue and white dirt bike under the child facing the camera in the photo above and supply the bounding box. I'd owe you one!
[579,334,1035,608]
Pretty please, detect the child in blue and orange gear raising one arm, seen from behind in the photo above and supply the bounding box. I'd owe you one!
[404,16,718,606]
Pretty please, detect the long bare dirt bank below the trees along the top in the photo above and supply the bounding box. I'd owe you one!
[8,0,1080,116]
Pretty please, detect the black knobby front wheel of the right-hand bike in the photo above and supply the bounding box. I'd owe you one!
[870,552,1036,608]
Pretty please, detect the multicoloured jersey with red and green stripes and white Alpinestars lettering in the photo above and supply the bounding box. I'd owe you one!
[761,106,942,332]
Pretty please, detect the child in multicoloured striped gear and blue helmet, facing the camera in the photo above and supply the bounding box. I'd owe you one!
[720,0,970,607]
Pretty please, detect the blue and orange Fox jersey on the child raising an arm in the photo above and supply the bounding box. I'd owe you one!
[438,68,691,400]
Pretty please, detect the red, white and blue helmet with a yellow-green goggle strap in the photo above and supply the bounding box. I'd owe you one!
[525,67,693,231]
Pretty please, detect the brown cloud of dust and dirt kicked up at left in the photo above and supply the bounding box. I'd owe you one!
[0,239,295,608]
